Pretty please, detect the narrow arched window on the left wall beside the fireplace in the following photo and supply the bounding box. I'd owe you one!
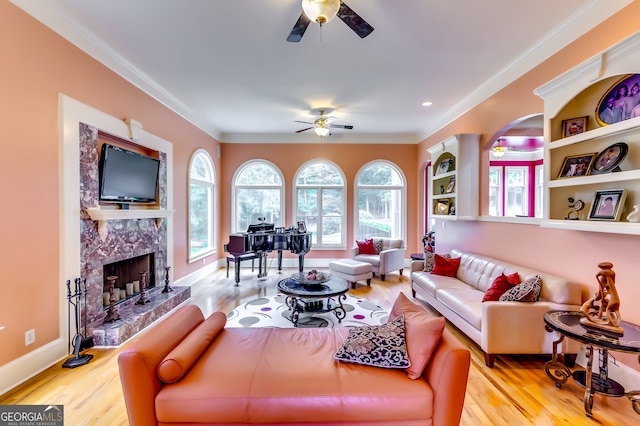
[189,149,215,262]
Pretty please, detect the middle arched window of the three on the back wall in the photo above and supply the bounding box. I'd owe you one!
[294,160,347,249]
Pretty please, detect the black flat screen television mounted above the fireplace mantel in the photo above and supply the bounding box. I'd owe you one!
[99,144,160,208]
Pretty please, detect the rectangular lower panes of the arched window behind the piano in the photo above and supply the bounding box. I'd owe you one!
[236,188,281,231]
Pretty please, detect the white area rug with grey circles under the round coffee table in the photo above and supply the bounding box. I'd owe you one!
[226,294,389,328]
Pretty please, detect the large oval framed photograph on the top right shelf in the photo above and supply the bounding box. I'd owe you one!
[595,74,640,126]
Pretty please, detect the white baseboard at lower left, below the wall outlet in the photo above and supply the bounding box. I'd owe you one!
[0,339,69,395]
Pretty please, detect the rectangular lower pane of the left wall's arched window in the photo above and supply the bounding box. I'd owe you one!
[189,184,213,256]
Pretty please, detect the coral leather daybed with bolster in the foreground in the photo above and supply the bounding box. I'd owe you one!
[118,299,470,426]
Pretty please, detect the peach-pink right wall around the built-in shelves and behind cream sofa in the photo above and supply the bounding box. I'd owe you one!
[418,1,640,368]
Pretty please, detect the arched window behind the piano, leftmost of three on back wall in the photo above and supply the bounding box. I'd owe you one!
[231,160,285,232]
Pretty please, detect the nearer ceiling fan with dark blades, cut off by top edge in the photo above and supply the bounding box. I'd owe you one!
[287,0,373,43]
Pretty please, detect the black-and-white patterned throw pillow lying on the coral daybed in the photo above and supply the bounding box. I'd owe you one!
[334,315,411,368]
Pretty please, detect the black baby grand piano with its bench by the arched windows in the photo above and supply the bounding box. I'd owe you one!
[224,222,311,286]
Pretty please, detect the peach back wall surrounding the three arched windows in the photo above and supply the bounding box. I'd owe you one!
[219,143,422,258]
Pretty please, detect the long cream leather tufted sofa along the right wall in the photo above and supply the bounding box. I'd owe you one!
[411,249,582,367]
